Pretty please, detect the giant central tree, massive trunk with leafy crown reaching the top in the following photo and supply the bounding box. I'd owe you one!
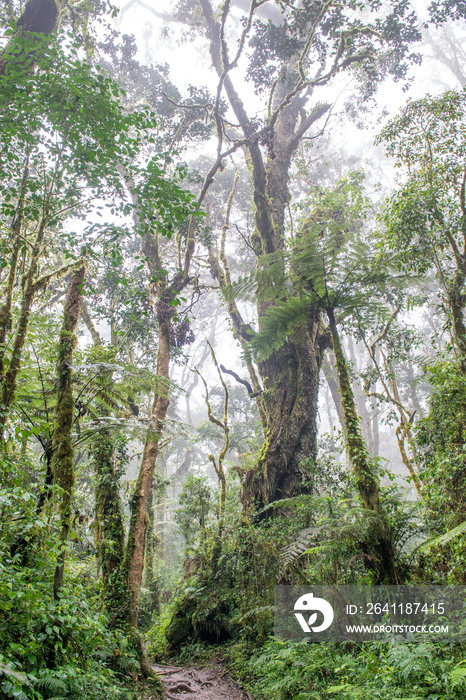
[177,0,419,506]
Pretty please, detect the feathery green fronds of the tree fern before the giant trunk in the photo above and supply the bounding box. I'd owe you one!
[233,172,396,360]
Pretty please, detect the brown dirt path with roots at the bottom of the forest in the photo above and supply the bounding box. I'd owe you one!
[152,664,252,700]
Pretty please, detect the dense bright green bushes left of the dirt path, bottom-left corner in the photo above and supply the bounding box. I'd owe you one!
[0,458,143,700]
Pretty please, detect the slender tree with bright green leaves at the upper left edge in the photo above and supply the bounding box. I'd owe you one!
[0,30,177,436]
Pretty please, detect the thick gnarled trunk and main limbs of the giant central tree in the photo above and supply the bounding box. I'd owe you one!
[199,0,330,507]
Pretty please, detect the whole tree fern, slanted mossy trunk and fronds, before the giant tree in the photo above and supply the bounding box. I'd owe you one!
[246,172,399,583]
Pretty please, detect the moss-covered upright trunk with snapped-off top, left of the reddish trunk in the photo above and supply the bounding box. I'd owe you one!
[51,266,85,598]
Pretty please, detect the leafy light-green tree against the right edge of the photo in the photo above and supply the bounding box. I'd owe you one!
[378,91,466,374]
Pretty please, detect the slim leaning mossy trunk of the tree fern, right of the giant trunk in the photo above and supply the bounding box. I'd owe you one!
[327,308,399,584]
